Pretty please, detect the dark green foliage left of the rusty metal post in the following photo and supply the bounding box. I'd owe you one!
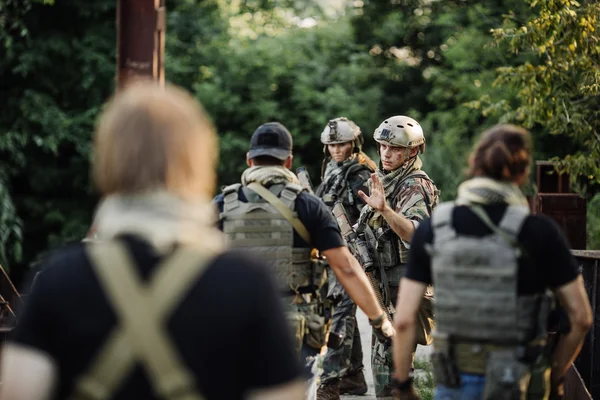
[0,0,116,272]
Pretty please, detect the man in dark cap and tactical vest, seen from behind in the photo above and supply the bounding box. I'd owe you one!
[214,122,394,396]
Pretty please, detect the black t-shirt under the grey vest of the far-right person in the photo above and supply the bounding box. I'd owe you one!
[405,204,579,294]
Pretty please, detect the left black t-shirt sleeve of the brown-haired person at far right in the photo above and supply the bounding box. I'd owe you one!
[404,219,433,285]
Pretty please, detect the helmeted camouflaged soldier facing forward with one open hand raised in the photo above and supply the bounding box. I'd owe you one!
[357,116,439,398]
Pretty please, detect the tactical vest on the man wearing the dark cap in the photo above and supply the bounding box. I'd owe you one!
[220,183,323,293]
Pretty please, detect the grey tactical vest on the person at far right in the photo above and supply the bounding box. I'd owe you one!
[431,203,539,344]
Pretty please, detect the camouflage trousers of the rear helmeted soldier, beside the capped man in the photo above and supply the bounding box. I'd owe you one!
[321,291,363,383]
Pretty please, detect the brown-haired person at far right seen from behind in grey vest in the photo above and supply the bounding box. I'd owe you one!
[394,125,592,400]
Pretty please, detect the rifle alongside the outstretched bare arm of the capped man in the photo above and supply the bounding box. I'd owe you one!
[332,201,395,322]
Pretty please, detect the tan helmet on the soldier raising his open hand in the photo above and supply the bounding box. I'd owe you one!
[373,115,425,153]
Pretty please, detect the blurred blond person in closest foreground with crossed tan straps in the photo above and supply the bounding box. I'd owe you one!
[0,82,305,400]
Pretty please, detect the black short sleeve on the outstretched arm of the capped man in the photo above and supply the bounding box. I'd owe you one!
[296,193,346,251]
